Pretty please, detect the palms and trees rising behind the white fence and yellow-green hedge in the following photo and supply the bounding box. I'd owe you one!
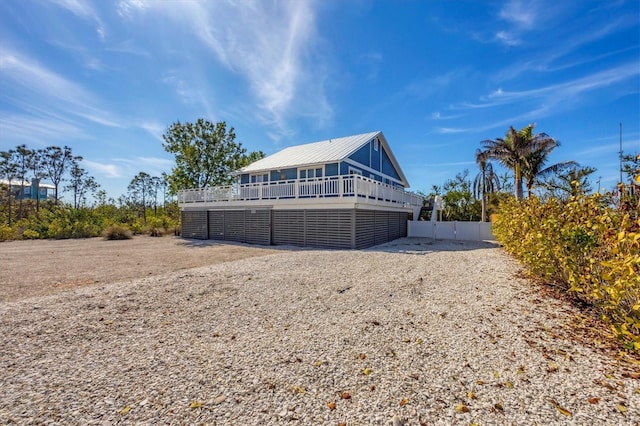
[422,124,640,221]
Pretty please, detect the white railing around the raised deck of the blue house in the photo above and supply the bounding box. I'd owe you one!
[178,175,423,207]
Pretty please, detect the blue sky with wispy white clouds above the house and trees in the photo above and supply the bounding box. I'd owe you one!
[0,0,640,197]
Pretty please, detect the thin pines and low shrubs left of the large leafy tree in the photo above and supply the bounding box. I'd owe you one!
[0,145,180,241]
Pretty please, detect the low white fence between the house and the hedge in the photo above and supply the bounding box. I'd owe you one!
[407,220,495,241]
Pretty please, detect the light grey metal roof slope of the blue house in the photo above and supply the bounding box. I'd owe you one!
[240,131,382,173]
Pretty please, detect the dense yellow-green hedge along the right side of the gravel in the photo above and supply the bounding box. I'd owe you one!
[493,194,640,351]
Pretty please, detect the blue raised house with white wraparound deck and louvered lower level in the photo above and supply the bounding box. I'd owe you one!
[178,131,423,249]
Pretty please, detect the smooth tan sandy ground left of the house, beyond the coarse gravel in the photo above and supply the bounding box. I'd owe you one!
[0,236,278,302]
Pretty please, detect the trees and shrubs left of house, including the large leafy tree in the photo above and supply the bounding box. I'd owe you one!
[0,119,264,241]
